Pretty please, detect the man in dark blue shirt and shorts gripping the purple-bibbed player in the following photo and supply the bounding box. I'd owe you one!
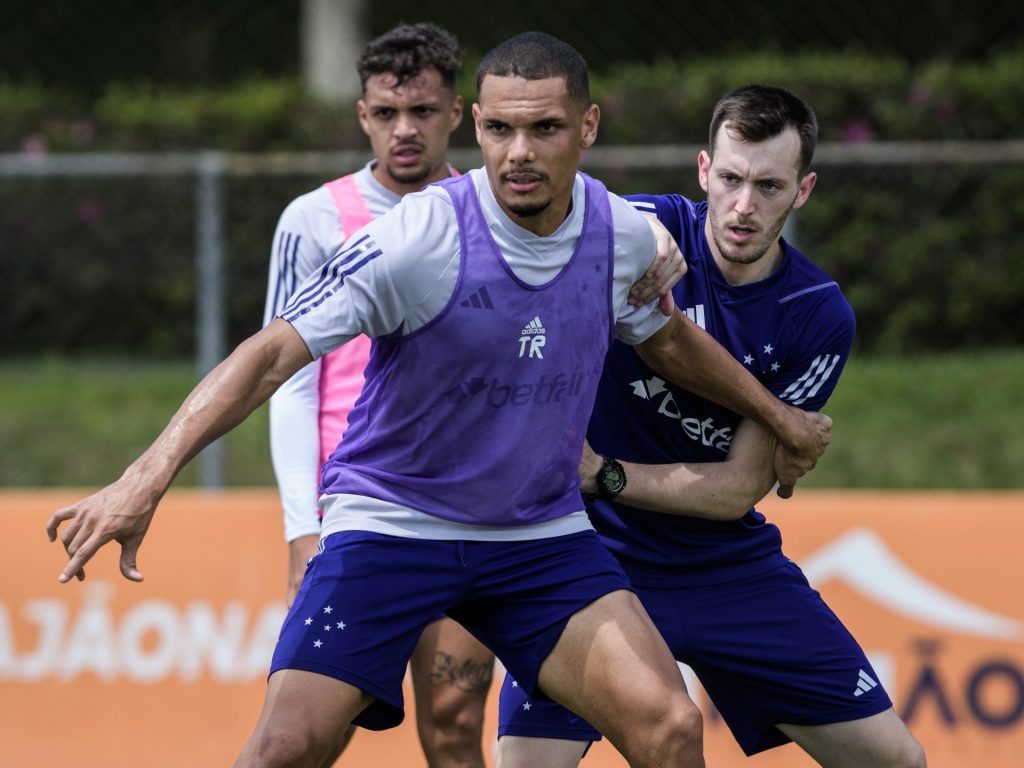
[499,85,925,768]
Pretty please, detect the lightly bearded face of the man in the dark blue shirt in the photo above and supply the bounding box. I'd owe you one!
[697,123,816,282]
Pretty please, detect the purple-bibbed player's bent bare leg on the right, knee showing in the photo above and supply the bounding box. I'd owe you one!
[538,590,705,768]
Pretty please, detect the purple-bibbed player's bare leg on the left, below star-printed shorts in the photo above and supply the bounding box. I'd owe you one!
[234,670,374,768]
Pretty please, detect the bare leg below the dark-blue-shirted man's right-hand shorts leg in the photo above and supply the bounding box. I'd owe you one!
[778,709,928,768]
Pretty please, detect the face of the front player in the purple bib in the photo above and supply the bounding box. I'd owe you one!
[473,75,600,236]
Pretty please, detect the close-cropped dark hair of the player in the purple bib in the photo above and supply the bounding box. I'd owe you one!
[476,32,590,104]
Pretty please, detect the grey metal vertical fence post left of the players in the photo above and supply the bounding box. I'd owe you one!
[196,152,227,488]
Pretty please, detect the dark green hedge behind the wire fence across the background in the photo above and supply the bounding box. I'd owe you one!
[0,49,1024,357]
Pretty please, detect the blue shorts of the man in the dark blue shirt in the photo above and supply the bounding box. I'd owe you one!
[498,562,892,755]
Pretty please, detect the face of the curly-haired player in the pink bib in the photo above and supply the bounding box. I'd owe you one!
[356,69,462,195]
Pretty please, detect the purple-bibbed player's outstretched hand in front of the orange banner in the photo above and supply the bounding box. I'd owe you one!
[46,477,157,583]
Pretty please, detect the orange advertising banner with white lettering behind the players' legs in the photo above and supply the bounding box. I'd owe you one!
[0,489,1024,768]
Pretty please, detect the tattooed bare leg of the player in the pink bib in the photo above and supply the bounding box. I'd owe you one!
[412,618,495,768]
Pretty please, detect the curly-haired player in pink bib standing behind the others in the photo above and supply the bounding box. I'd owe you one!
[264,24,494,768]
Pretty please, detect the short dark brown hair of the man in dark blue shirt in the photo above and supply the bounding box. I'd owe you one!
[708,85,818,177]
